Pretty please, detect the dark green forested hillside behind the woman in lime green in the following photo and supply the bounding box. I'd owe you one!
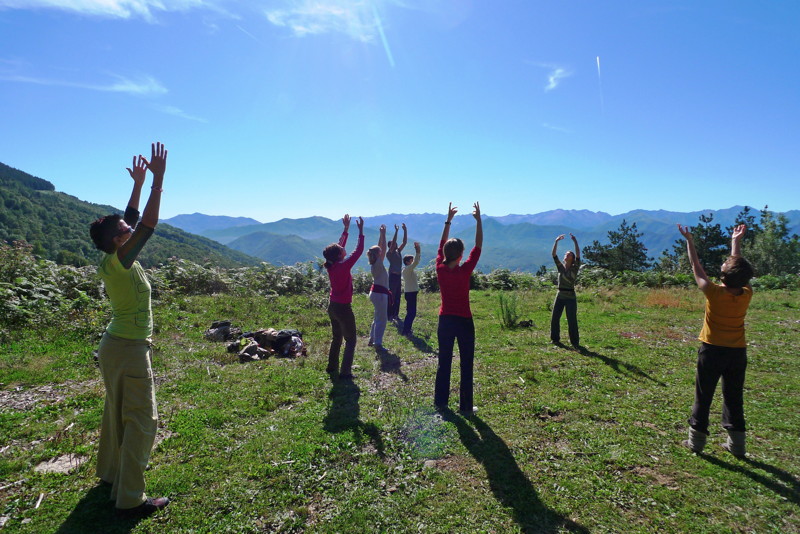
[0,163,258,267]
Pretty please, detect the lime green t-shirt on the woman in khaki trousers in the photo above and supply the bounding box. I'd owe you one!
[100,252,153,339]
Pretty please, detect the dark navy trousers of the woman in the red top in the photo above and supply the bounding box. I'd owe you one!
[433,315,475,412]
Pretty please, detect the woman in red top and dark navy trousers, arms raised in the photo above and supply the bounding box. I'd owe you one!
[433,202,483,415]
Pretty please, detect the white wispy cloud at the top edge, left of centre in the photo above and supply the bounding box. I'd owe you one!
[264,0,379,42]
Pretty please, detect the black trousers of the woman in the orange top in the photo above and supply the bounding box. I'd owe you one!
[689,343,747,434]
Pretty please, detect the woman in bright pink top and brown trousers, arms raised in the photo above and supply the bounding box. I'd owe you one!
[322,214,364,378]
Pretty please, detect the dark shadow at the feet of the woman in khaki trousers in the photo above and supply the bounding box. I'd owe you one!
[56,485,142,534]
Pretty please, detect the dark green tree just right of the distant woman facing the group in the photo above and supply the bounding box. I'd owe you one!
[583,219,650,272]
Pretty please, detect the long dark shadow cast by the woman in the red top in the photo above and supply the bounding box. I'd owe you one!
[442,410,589,533]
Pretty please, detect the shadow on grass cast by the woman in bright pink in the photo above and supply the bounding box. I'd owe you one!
[323,378,385,458]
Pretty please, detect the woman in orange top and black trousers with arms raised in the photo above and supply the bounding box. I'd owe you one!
[678,224,753,457]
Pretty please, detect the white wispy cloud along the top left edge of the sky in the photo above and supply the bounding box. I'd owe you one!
[0,0,210,20]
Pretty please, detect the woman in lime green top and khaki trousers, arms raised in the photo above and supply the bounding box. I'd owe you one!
[89,143,169,517]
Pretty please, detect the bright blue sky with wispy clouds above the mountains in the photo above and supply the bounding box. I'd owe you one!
[0,0,800,222]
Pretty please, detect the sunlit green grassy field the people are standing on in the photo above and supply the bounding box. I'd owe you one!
[0,288,800,533]
